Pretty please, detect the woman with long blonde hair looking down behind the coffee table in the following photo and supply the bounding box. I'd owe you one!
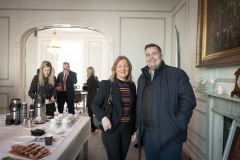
[28,61,57,116]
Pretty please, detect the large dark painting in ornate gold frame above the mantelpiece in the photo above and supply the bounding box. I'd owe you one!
[196,0,240,68]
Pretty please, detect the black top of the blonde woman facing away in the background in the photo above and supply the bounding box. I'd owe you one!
[87,76,98,107]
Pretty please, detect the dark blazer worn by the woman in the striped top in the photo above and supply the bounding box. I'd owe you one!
[91,80,136,134]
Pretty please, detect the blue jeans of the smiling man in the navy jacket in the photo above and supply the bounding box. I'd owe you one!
[143,131,182,160]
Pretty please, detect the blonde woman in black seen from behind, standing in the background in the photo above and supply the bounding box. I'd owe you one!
[87,67,98,132]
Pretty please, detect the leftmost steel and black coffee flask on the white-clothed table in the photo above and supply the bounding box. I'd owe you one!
[9,98,21,125]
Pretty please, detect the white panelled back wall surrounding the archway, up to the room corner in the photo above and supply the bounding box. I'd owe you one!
[0,0,172,108]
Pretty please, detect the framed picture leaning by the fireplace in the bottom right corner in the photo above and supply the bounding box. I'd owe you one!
[222,120,240,160]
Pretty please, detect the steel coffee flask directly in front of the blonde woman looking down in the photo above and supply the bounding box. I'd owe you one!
[34,94,46,124]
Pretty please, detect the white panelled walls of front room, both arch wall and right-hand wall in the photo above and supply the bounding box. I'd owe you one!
[0,0,240,159]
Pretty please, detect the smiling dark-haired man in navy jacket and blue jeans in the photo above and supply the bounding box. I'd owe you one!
[136,44,196,160]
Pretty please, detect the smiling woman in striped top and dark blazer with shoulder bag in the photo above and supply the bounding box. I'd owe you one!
[91,56,137,160]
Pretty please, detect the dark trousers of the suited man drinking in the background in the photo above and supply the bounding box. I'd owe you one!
[57,91,75,114]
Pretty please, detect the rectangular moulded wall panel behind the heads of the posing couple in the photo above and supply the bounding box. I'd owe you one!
[119,17,166,81]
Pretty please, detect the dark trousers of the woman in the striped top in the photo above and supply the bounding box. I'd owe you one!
[102,122,132,160]
